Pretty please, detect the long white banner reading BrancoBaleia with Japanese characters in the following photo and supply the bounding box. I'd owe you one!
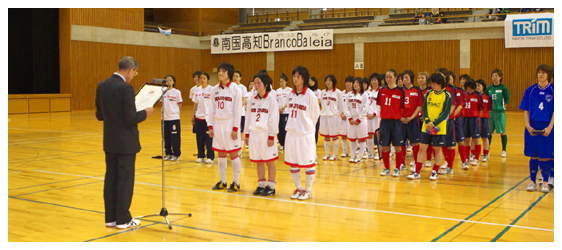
[211,29,334,54]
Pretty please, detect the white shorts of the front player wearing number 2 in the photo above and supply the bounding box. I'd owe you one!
[246,130,279,162]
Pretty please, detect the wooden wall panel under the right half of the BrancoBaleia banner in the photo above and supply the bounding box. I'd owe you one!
[273,44,354,90]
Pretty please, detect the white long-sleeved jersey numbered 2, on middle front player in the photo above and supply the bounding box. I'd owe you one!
[244,90,279,137]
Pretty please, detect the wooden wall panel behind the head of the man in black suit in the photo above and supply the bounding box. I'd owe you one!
[71,41,201,110]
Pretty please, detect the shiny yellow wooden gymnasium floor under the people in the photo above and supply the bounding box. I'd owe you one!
[8,108,554,242]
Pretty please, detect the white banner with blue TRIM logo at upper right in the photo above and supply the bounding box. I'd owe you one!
[504,13,554,48]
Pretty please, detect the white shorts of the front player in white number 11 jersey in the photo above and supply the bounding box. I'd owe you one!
[285,131,316,168]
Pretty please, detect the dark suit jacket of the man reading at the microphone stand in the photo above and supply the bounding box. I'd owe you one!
[96,74,146,154]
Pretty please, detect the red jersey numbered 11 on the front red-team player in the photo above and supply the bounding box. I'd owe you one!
[377,86,404,120]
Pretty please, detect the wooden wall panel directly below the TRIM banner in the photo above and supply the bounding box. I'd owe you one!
[470,39,554,111]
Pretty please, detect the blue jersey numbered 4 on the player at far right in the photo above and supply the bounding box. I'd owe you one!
[519,83,554,122]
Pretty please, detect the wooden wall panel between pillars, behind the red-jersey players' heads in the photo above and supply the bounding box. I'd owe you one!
[364,40,460,85]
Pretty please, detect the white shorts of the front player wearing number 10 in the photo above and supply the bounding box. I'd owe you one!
[208,120,238,153]
